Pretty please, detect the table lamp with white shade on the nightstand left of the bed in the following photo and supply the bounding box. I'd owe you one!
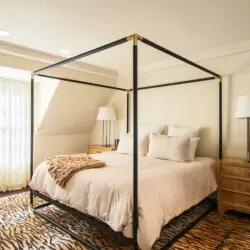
[97,107,116,147]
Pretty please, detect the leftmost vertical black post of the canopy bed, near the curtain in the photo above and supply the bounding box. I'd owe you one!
[30,74,35,209]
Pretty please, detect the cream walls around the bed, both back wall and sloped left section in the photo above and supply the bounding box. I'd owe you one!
[0,48,250,164]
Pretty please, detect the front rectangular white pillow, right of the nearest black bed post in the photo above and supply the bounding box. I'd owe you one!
[147,134,190,162]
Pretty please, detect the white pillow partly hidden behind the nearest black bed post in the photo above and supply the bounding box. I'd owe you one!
[116,133,148,156]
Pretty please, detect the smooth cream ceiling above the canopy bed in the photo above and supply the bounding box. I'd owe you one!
[0,0,250,72]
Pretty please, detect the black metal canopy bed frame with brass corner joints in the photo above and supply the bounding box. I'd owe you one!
[30,34,222,249]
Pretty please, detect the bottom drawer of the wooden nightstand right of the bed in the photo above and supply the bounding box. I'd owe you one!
[221,190,250,209]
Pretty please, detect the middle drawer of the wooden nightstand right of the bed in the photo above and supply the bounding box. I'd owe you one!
[221,176,250,193]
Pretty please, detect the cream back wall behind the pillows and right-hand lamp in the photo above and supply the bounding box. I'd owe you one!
[106,52,250,158]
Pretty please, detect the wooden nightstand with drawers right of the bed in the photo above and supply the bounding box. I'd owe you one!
[217,158,250,214]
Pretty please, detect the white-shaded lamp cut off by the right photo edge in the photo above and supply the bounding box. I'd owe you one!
[234,96,250,162]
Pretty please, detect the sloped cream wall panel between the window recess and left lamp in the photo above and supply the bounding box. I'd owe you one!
[38,81,114,134]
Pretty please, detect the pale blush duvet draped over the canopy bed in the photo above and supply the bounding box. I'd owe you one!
[30,152,217,250]
